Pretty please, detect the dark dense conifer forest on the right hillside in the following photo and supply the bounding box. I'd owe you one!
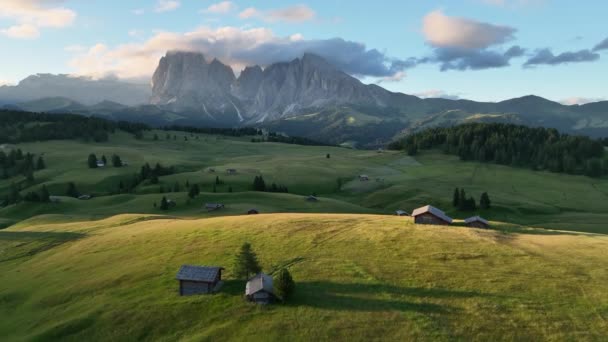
[389,123,608,177]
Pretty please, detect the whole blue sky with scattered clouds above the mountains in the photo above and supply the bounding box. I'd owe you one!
[0,0,608,104]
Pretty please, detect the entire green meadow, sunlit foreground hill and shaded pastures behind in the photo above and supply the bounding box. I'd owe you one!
[0,132,608,341]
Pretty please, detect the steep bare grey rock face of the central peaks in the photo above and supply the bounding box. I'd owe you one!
[152,52,389,122]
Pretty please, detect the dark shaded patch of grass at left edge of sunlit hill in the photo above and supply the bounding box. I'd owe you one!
[0,231,86,262]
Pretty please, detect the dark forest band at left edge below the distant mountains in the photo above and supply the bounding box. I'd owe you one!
[0,110,149,143]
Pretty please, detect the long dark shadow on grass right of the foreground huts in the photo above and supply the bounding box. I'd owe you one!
[290,281,488,313]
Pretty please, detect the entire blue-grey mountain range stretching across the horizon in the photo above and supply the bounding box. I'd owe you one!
[0,51,608,146]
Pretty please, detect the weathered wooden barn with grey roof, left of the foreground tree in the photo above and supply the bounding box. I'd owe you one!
[175,265,224,296]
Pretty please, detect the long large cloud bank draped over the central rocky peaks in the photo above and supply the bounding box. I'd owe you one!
[69,27,413,79]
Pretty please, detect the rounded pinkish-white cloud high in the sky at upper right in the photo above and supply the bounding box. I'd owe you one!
[422,10,516,49]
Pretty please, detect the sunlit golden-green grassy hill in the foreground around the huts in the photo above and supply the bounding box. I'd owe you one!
[0,214,608,341]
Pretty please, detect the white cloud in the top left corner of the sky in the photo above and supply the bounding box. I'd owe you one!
[0,0,76,39]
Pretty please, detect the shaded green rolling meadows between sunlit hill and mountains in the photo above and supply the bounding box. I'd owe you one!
[0,132,608,233]
